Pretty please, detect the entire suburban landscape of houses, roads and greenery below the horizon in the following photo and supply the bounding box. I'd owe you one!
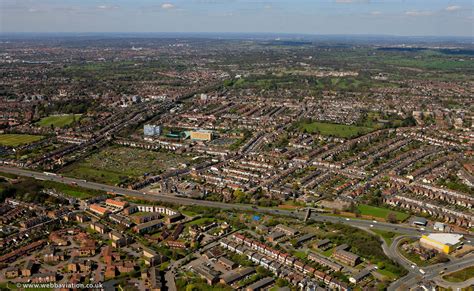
[0,35,474,291]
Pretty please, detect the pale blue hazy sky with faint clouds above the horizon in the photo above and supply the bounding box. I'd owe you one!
[0,0,474,37]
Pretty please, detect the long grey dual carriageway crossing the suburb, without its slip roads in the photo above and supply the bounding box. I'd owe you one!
[0,166,474,241]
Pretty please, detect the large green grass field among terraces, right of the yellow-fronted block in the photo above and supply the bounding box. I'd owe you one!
[299,122,373,138]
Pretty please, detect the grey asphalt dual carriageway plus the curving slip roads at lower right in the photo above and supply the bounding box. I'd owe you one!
[0,166,474,290]
